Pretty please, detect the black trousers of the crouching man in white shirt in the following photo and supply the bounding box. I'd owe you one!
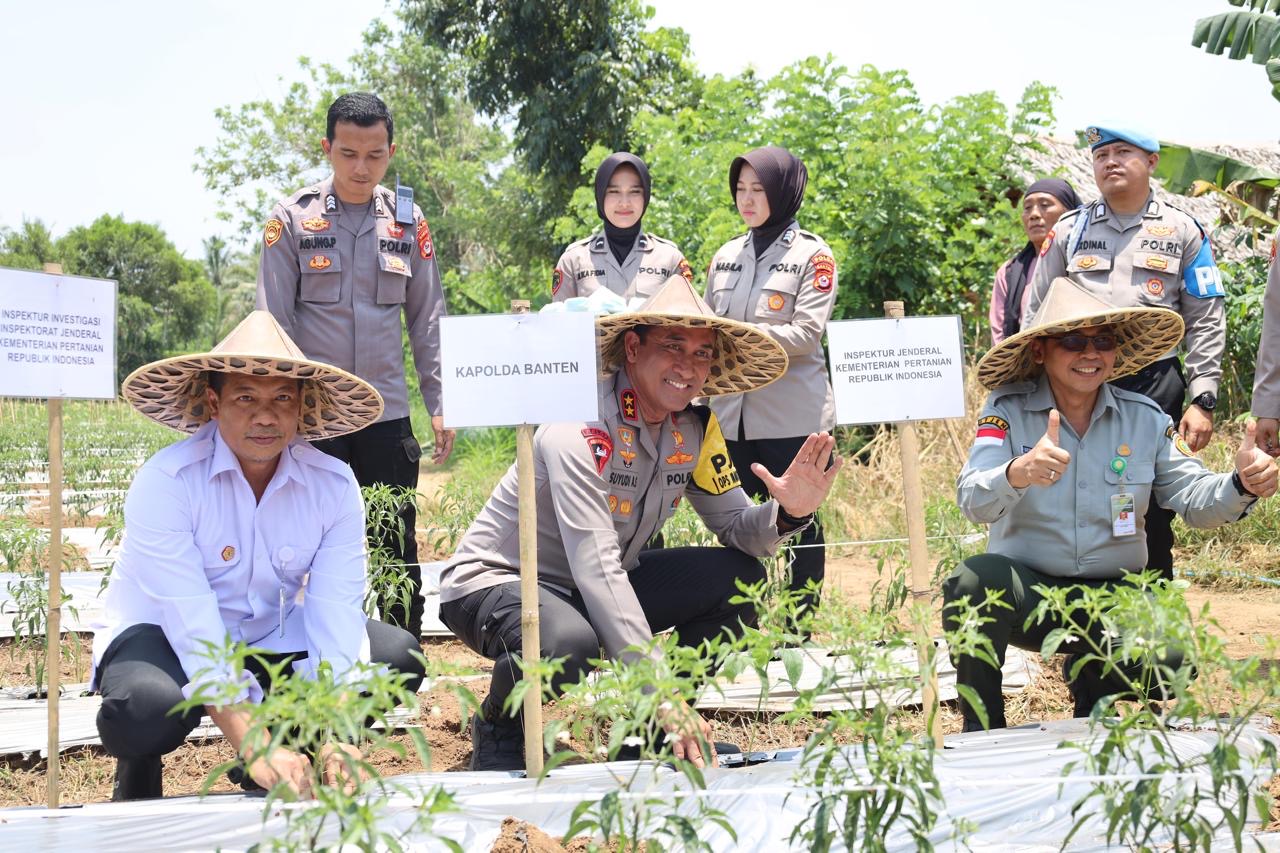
[97,619,426,758]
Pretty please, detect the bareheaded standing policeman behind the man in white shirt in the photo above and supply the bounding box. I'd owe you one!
[257,92,453,637]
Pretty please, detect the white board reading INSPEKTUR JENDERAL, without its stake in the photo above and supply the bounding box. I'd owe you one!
[827,316,965,424]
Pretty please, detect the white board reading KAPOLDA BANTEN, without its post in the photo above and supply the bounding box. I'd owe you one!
[440,311,600,429]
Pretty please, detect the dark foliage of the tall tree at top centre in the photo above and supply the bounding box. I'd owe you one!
[403,0,695,211]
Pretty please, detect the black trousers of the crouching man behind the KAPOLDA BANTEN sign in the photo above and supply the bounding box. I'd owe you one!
[440,548,764,720]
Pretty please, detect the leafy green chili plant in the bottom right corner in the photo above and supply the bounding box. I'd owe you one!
[1032,573,1280,852]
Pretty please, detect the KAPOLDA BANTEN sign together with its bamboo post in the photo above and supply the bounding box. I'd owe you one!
[440,306,600,779]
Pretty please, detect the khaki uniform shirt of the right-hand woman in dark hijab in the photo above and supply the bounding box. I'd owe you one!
[707,223,836,441]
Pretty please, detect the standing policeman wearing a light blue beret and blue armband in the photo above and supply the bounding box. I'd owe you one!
[1023,127,1226,578]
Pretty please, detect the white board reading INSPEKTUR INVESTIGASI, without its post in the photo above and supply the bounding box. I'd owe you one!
[0,268,116,400]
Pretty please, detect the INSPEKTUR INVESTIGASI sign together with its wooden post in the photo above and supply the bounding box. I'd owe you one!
[0,264,115,808]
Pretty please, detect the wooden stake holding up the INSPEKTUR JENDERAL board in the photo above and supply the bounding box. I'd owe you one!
[884,302,942,747]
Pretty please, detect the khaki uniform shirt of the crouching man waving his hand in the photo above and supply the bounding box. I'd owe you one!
[440,368,794,657]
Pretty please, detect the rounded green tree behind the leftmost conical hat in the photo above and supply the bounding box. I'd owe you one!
[56,215,215,377]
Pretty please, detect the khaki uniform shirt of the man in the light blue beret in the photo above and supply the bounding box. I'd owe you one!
[1023,196,1226,398]
